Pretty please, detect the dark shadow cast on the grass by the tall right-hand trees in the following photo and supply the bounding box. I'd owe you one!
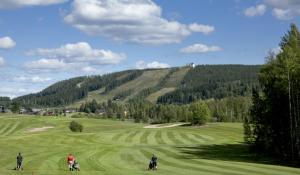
[177,143,299,168]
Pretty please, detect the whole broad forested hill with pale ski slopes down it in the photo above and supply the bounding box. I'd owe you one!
[13,65,261,107]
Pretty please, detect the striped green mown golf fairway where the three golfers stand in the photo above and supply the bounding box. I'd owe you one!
[0,117,300,175]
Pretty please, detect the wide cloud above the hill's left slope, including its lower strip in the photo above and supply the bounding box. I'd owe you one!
[24,42,126,72]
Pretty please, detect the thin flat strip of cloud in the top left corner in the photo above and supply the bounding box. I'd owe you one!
[0,0,68,9]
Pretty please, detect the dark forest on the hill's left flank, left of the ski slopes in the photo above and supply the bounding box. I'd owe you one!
[13,70,142,107]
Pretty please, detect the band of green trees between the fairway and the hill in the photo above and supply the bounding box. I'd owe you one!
[79,97,251,124]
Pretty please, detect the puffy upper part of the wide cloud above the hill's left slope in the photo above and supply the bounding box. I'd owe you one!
[27,42,126,65]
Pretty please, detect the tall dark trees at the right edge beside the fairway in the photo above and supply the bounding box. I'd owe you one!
[244,24,300,165]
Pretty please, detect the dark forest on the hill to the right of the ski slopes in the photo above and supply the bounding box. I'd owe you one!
[158,65,261,104]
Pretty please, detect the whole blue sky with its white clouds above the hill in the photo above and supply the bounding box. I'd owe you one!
[0,0,300,97]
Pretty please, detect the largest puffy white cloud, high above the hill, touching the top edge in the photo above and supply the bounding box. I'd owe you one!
[64,0,214,44]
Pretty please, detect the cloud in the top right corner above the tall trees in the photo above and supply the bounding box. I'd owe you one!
[264,0,300,20]
